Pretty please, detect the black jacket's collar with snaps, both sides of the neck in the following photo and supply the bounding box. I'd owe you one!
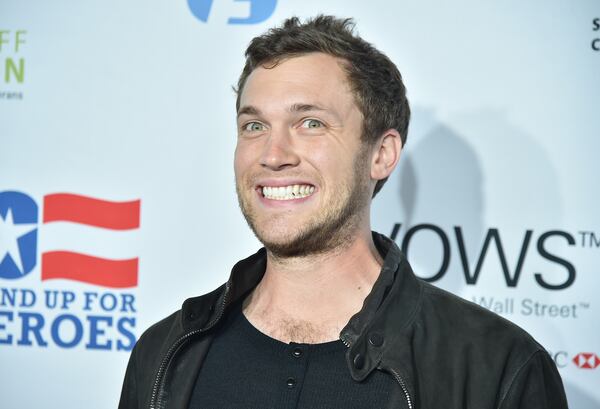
[181,232,422,393]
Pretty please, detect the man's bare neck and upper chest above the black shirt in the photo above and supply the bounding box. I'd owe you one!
[244,226,383,343]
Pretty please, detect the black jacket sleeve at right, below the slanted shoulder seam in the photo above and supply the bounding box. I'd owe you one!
[499,350,568,409]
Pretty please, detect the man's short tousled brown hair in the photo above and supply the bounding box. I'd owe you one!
[236,15,410,196]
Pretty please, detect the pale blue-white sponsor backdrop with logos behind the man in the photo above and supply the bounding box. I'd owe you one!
[0,0,600,409]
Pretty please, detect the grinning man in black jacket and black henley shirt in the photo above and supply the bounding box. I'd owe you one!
[120,16,567,409]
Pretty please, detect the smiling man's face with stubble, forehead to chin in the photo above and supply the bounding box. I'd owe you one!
[234,53,372,257]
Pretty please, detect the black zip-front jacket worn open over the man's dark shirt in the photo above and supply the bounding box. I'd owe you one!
[119,233,567,409]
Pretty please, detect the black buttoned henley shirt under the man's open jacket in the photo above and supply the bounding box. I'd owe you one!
[189,304,394,409]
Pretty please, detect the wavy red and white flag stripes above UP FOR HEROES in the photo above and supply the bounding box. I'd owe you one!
[41,193,140,288]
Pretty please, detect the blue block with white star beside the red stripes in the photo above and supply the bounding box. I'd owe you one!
[0,191,38,279]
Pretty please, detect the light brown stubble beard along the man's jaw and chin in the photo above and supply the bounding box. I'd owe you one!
[236,149,371,259]
